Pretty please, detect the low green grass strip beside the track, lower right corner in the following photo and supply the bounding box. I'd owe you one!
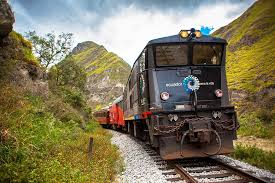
[231,145,275,173]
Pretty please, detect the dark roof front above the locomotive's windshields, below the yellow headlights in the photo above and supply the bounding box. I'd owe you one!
[147,34,227,45]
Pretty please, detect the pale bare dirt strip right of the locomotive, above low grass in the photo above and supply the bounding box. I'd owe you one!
[234,136,275,152]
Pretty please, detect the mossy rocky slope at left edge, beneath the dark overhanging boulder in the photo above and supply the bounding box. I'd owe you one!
[0,31,49,95]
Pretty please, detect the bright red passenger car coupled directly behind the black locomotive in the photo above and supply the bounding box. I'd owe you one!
[109,96,125,128]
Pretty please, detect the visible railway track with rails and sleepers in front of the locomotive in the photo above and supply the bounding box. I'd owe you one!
[145,146,272,183]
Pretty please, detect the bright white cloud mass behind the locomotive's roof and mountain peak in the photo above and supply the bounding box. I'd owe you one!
[81,4,249,64]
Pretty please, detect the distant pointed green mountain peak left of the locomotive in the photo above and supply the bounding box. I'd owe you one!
[71,41,131,108]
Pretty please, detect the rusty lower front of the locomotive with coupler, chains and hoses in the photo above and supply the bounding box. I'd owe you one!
[124,108,238,160]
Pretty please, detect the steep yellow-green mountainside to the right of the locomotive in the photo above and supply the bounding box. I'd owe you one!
[213,0,275,116]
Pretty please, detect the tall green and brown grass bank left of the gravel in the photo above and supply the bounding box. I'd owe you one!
[0,85,122,182]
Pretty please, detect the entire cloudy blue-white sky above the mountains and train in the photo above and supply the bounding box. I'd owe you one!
[9,0,255,65]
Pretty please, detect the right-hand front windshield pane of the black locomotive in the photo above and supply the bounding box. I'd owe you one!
[193,45,222,65]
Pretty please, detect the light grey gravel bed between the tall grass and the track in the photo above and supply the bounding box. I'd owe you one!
[110,130,170,183]
